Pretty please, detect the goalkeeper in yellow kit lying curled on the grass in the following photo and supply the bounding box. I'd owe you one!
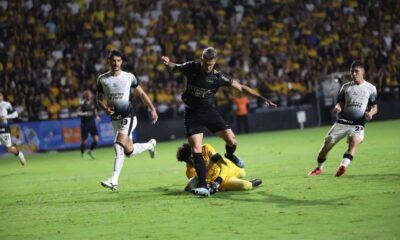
[176,143,262,193]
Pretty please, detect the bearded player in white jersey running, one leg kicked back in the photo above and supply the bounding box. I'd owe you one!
[97,50,158,190]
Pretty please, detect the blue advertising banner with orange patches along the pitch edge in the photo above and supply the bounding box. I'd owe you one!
[0,115,136,154]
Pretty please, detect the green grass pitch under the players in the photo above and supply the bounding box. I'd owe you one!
[0,120,400,240]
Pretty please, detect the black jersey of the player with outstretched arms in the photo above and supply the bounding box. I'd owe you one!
[175,61,232,108]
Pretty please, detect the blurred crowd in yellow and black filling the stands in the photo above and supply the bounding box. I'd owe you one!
[0,0,400,121]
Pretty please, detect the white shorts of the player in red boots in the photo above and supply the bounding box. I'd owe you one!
[325,123,364,144]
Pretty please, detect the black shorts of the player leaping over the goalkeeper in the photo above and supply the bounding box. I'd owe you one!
[185,108,231,137]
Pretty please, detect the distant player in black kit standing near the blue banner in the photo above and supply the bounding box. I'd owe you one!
[78,90,100,159]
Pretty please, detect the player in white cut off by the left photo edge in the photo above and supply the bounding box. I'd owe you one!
[0,92,26,166]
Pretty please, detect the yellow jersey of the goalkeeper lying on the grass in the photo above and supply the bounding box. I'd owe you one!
[186,144,240,182]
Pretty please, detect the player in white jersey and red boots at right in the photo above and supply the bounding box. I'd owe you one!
[308,61,378,177]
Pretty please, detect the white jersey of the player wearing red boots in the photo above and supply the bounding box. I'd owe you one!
[338,81,377,125]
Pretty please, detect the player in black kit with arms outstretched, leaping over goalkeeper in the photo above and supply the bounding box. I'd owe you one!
[161,47,276,197]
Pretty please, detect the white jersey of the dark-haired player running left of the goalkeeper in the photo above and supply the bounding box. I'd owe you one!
[97,71,138,119]
